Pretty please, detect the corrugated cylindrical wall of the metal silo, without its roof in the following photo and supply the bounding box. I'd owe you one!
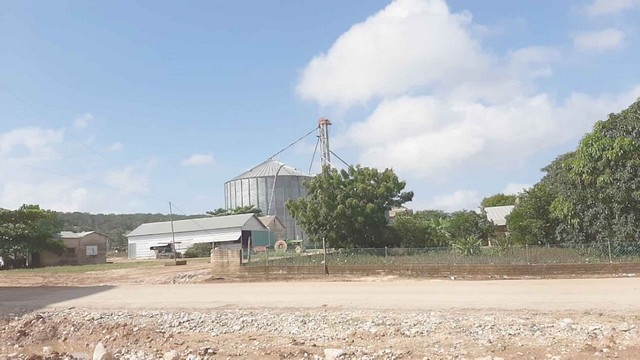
[224,175,310,239]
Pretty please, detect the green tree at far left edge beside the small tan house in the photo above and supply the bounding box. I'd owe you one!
[0,205,63,259]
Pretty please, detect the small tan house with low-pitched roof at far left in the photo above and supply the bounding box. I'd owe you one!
[32,231,108,266]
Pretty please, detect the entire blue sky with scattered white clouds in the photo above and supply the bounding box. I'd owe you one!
[0,0,640,213]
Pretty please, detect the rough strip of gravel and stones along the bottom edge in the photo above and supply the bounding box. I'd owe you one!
[0,309,640,360]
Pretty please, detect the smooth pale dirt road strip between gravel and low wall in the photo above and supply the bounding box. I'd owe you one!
[5,278,640,314]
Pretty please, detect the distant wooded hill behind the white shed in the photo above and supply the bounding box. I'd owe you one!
[57,212,206,249]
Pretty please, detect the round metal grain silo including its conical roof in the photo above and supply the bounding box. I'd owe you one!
[224,160,311,239]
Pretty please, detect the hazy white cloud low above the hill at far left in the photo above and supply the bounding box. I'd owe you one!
[0,127,158,212]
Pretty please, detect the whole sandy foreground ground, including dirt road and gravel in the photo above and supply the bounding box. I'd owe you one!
[0,262,640,360]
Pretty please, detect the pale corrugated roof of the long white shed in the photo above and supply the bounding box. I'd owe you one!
[127,214,255,237]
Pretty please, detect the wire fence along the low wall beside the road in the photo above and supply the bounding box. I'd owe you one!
[244,243,640,266]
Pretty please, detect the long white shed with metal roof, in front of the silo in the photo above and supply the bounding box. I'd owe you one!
[127,214,266,259]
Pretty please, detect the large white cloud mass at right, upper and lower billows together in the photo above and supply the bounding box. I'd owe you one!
[297,0,640,180]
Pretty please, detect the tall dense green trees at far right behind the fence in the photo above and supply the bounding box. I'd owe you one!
[507,99,640,244]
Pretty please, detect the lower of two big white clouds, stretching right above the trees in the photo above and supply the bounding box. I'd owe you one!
[342,87,640,178]
